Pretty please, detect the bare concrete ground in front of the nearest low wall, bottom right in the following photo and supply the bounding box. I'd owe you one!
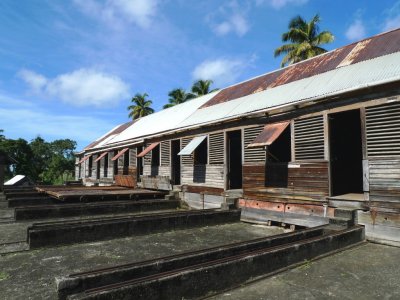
[209,243,400,300]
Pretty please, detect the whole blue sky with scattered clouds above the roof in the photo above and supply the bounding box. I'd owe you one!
[0,0,400,149]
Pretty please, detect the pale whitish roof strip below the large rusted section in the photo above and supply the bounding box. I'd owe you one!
[179,52,400,127]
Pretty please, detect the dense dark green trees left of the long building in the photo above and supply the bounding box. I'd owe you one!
[0,130,76,184]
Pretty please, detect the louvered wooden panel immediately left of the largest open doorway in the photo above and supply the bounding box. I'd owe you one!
[294,115,324,160]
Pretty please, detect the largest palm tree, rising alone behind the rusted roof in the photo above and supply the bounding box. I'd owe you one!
[274,14,334,67]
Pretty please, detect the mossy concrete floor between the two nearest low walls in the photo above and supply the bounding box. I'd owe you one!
[0,222,284,299]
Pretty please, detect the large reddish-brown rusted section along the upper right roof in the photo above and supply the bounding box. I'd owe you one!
[200,30,400,108]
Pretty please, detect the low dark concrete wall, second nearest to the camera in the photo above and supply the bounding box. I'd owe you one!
[27,210,240,249]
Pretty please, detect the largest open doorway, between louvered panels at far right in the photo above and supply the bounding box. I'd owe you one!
[329,109,363,196]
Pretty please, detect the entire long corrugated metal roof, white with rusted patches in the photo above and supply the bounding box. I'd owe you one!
[80,30,400,150]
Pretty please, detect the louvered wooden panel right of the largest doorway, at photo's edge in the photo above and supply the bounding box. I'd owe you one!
[365,102,400,157]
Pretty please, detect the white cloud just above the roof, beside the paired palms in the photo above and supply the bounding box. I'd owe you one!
[192,58,247,87]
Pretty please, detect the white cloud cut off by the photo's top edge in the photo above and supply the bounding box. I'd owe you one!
[74,0,159,28]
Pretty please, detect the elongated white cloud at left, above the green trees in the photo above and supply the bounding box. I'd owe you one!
[19,69,129,107]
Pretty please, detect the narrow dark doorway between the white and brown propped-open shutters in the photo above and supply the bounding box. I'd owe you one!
[226,130,242,190]
